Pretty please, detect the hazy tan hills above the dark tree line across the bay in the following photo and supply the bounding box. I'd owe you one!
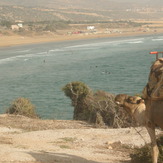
[0,0,163,21]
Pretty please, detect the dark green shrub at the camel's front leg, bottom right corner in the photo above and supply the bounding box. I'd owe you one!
[130,136,163,163]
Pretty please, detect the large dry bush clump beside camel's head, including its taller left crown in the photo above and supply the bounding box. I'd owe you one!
[63,82,132,128]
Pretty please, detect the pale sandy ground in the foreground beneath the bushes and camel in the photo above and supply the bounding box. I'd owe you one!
[0,115,162,163]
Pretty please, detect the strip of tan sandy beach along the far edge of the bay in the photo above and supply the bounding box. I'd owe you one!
[0,30,163,48]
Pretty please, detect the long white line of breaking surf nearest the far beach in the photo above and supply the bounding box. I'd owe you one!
[0,38,145,64]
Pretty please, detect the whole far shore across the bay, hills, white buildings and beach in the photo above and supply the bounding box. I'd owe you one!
[0,0,163,46]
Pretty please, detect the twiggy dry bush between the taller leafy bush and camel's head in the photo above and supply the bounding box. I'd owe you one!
[86,91,132,128]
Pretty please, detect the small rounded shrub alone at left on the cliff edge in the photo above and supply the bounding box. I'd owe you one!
[6,97,37,118]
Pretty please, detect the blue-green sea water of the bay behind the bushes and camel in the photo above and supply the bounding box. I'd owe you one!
[0,35,163,119]
